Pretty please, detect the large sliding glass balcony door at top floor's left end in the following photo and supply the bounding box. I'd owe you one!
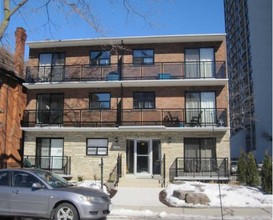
[39,53,65,81]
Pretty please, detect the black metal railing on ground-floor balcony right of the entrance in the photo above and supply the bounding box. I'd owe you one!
[169,157,229,181]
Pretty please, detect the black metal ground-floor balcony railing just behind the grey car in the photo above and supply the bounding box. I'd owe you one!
[23,155,71,175]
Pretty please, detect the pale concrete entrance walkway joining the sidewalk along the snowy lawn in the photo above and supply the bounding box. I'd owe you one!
[110,187,272,219]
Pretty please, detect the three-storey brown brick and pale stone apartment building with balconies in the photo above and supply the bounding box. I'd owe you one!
[22,34,230,184]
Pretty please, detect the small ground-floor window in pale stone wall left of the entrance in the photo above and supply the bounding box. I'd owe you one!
[86,138,108,156]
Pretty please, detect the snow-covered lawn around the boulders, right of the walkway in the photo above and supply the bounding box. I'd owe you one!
[166,182,272,208]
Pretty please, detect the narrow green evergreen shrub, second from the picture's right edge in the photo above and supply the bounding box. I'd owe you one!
[246,153,259,186]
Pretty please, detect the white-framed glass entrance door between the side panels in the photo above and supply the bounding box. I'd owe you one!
[136,140,151,173]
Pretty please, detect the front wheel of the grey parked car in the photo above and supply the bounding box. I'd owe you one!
[54,203,79,220]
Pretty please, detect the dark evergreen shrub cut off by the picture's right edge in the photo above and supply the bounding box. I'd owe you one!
[261,153,272,194]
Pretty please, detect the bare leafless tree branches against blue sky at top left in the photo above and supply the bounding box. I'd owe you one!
[0,0,161,41]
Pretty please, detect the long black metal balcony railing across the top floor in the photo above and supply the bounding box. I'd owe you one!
[26,61,226,83]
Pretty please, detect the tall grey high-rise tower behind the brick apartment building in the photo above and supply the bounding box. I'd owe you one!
[224,0,272,163]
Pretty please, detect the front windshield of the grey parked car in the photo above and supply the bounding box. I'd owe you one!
[35,170,68,188]
